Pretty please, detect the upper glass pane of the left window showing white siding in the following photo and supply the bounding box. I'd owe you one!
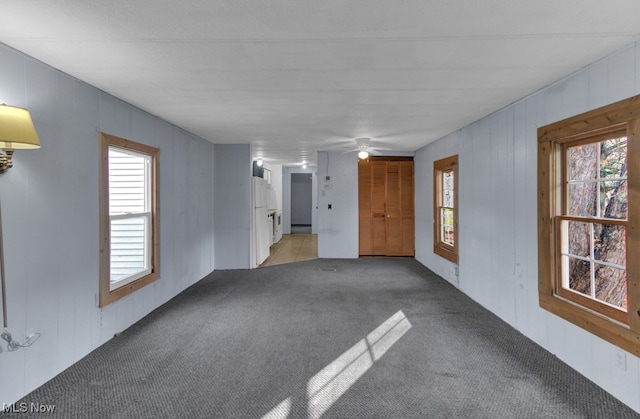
[109,147,150,215]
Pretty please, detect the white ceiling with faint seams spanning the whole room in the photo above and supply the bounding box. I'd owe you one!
[0,0,640,165]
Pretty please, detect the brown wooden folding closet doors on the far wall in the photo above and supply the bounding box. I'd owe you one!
[358,158,414,256]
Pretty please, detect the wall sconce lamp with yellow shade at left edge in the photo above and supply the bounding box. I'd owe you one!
[0,103,40,173]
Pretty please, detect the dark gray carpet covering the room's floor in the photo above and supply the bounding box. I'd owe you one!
[3,258,639,418]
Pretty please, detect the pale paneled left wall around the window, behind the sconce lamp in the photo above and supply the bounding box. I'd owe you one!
[0,45,215,404]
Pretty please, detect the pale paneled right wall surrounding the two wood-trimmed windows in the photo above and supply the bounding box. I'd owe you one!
[416,41,640,412]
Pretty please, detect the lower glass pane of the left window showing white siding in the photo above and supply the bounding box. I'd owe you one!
[110,216,148,282]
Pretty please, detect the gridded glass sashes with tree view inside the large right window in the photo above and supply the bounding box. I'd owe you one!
[558,131,628,321]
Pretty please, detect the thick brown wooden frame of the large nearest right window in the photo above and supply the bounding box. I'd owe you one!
[538,95,640,356]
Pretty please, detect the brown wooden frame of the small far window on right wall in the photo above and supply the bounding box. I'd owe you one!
[433,154,458,263]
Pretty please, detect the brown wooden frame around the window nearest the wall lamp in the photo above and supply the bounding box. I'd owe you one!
[98,132,160,307]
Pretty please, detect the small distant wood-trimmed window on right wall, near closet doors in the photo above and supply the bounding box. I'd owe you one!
[433,155,458,263]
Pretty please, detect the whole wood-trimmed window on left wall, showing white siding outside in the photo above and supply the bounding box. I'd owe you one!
[99,133,160,307]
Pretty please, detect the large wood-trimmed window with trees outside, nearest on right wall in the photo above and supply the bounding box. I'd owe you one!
[538,96,640,355]
